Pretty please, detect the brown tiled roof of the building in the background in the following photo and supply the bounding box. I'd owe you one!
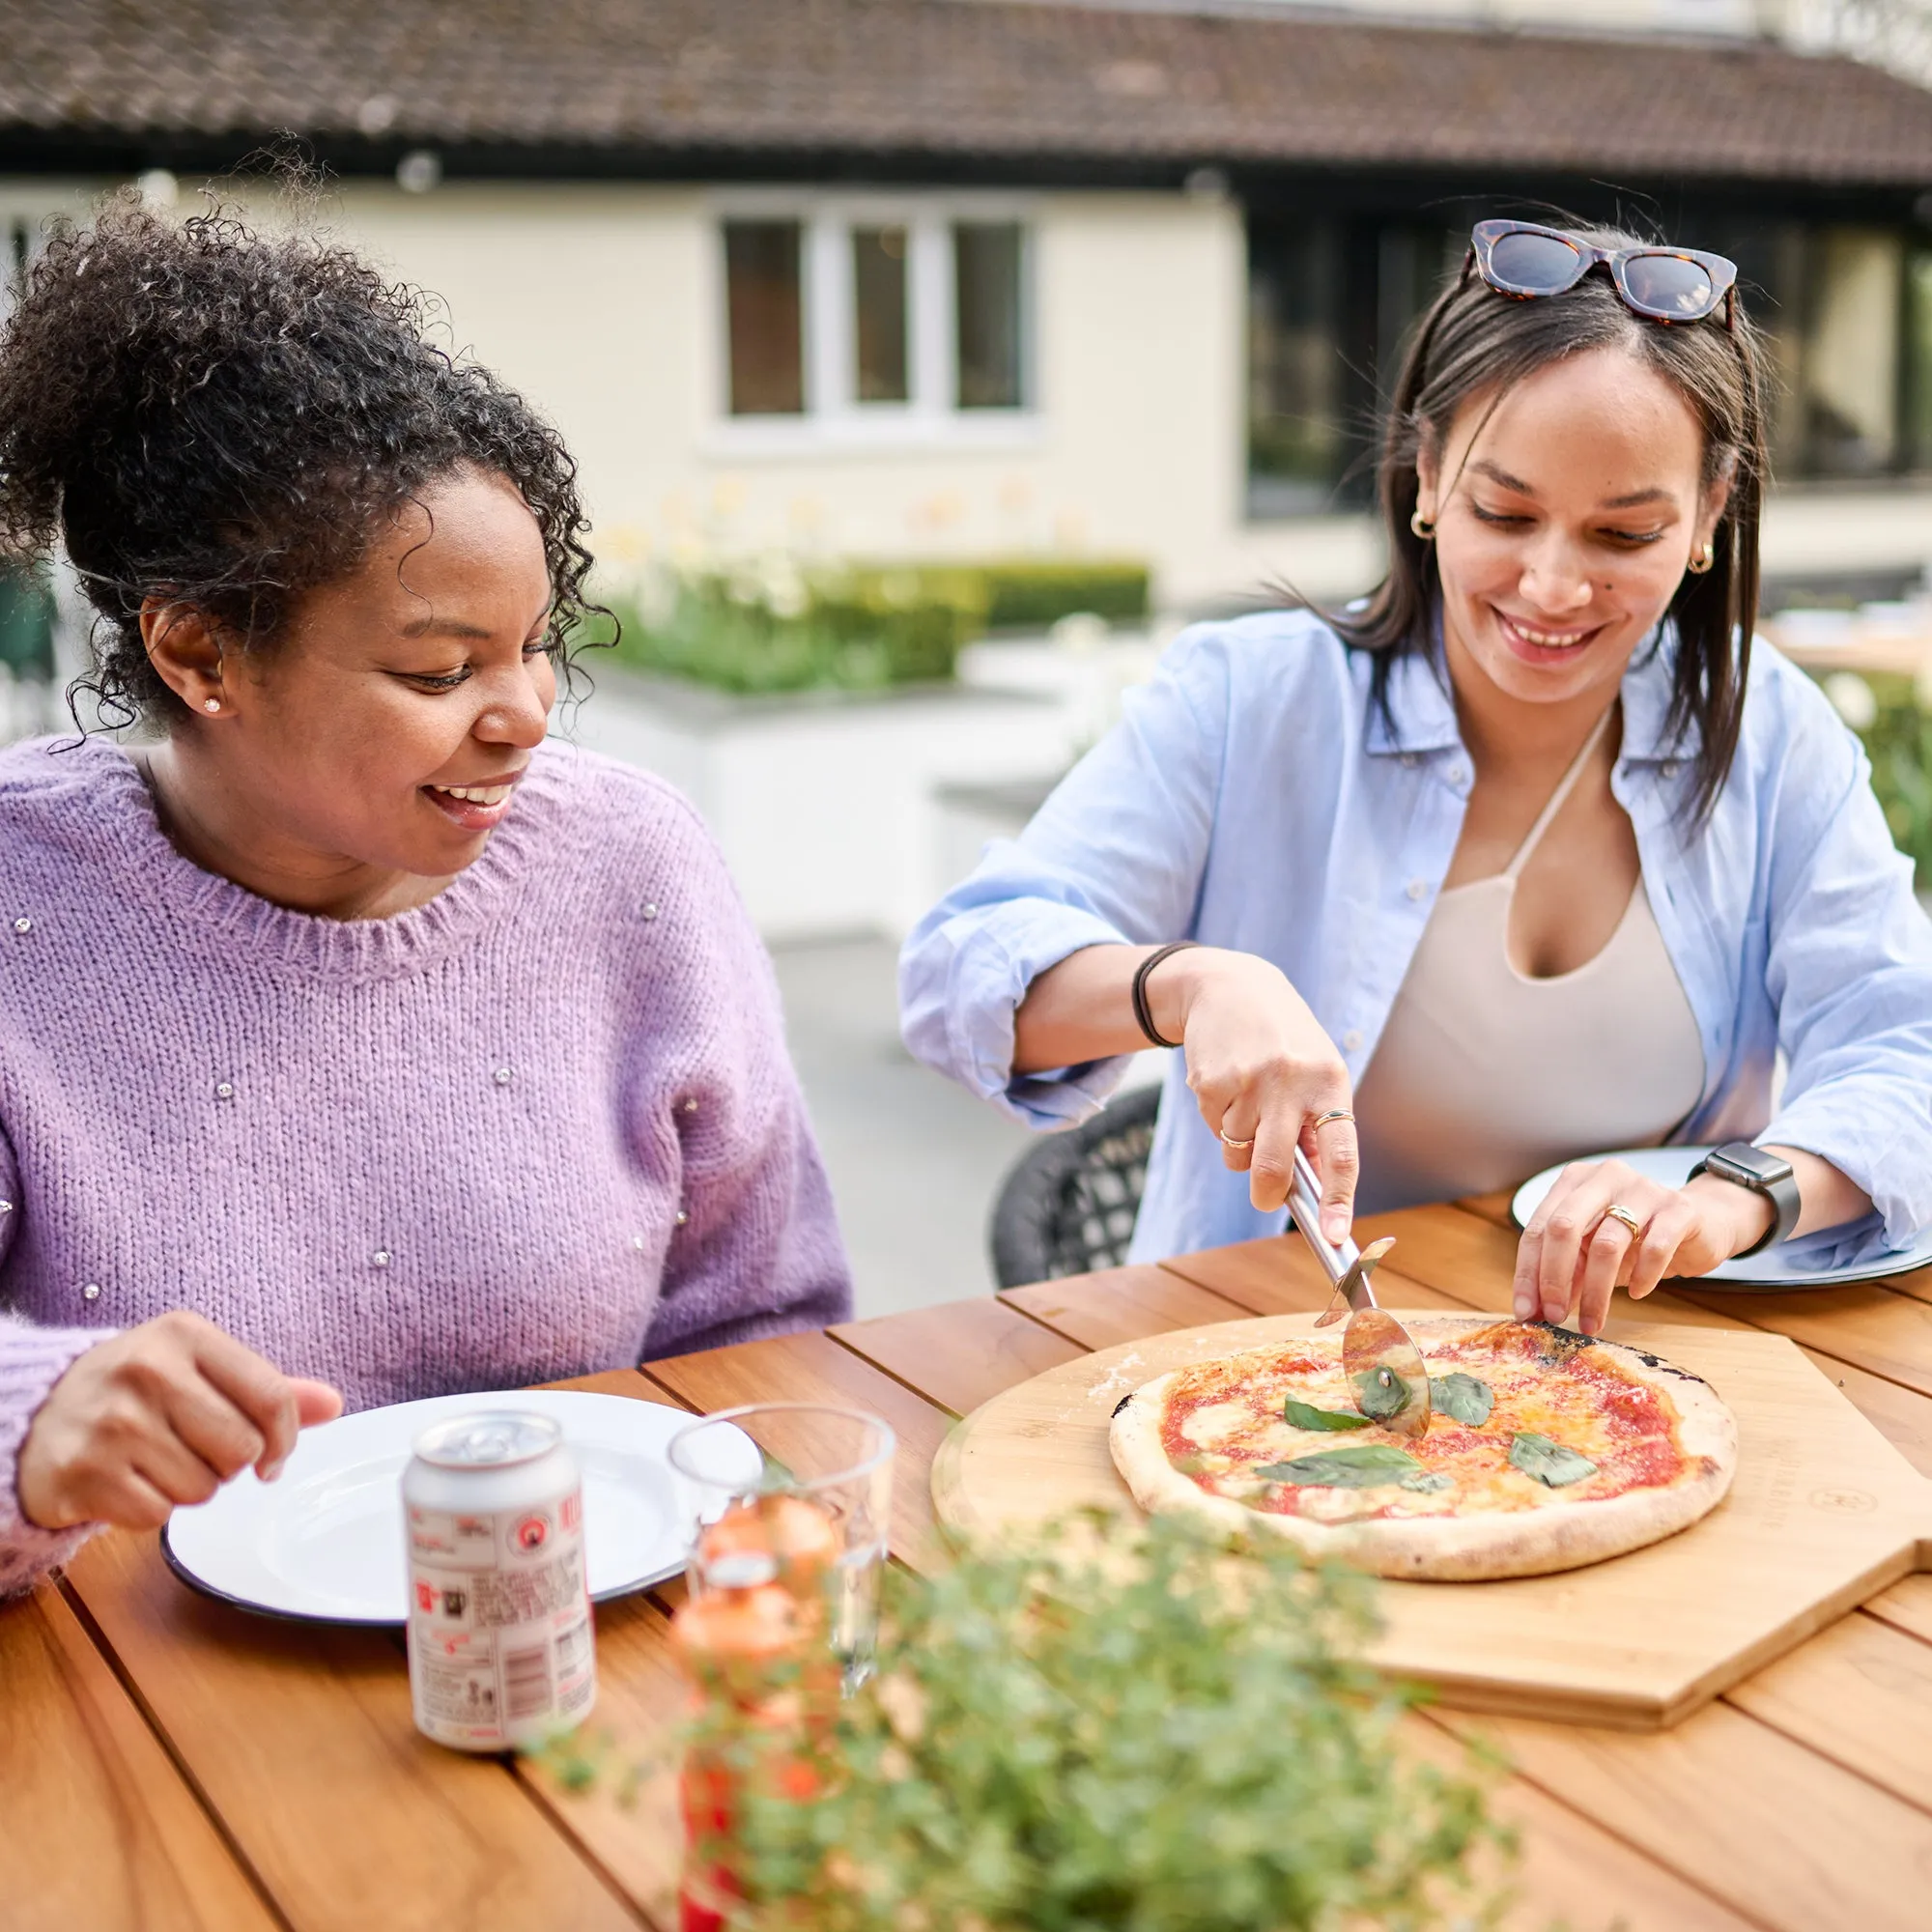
[14,0,1932,185]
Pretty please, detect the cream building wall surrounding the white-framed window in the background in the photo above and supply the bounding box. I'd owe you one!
[11,180,1932,611]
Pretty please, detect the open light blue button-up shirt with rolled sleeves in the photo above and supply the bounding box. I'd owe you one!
[900,612,1932,1262]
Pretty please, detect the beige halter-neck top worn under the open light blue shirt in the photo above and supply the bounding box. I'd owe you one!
[1354,707,1704,1213]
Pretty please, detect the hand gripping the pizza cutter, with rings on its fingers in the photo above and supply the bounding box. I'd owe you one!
[1146,947,1360,1242]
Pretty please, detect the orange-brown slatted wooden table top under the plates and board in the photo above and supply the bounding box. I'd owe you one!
[0,1198,1932,1932]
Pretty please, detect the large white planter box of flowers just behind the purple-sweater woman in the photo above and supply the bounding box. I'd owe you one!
[558,661,1080,939]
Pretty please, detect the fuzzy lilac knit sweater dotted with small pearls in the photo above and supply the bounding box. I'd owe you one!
[0,738,850,1594]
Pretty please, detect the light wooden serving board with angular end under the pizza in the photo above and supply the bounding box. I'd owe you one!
[933,1308,1932,1729]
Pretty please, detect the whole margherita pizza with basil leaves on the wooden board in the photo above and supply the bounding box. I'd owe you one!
[1111,1314,1737,1582]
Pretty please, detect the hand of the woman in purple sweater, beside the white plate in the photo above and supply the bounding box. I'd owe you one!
[15,1310,342,1530]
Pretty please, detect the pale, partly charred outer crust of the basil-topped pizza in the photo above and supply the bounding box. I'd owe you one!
[1109,1312,1737,1582]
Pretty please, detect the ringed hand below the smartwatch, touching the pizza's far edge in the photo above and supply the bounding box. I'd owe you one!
[1515,1161,1776,1335]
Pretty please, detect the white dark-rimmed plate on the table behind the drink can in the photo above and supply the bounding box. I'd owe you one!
[160,1389,726,1623]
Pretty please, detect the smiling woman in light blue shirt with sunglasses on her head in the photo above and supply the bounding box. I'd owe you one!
[900,220,1932,1331]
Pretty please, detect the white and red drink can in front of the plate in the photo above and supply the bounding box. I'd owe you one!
[402,1408,597,1750]
